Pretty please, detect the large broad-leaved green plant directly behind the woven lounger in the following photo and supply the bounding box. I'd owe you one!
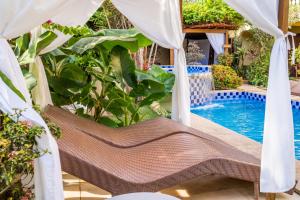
[43,29,174,127]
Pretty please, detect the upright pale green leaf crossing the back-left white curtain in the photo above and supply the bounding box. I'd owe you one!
[19,31,57,65]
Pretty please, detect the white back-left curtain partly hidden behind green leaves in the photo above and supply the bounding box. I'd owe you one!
[30,0,104,109]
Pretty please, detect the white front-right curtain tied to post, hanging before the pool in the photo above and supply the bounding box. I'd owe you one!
[225,0,295,193]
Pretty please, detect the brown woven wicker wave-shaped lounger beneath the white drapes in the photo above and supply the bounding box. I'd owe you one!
[44,107,260,199]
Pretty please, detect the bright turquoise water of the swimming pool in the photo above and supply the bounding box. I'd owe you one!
[192,99,300,160]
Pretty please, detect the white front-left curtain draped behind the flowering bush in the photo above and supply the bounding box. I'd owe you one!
[0,0,101,200]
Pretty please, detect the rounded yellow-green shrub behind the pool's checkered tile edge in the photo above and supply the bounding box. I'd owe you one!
[212,65,242,90]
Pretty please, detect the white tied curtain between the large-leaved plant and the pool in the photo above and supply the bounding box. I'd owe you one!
[112,0,190,125]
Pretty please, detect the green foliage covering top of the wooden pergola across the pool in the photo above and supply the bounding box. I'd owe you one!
[182,0,244,26]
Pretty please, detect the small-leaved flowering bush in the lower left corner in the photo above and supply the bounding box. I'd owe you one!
[0,111,47,199]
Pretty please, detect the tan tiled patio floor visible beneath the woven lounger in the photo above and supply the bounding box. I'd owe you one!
[64,171,300,200]
